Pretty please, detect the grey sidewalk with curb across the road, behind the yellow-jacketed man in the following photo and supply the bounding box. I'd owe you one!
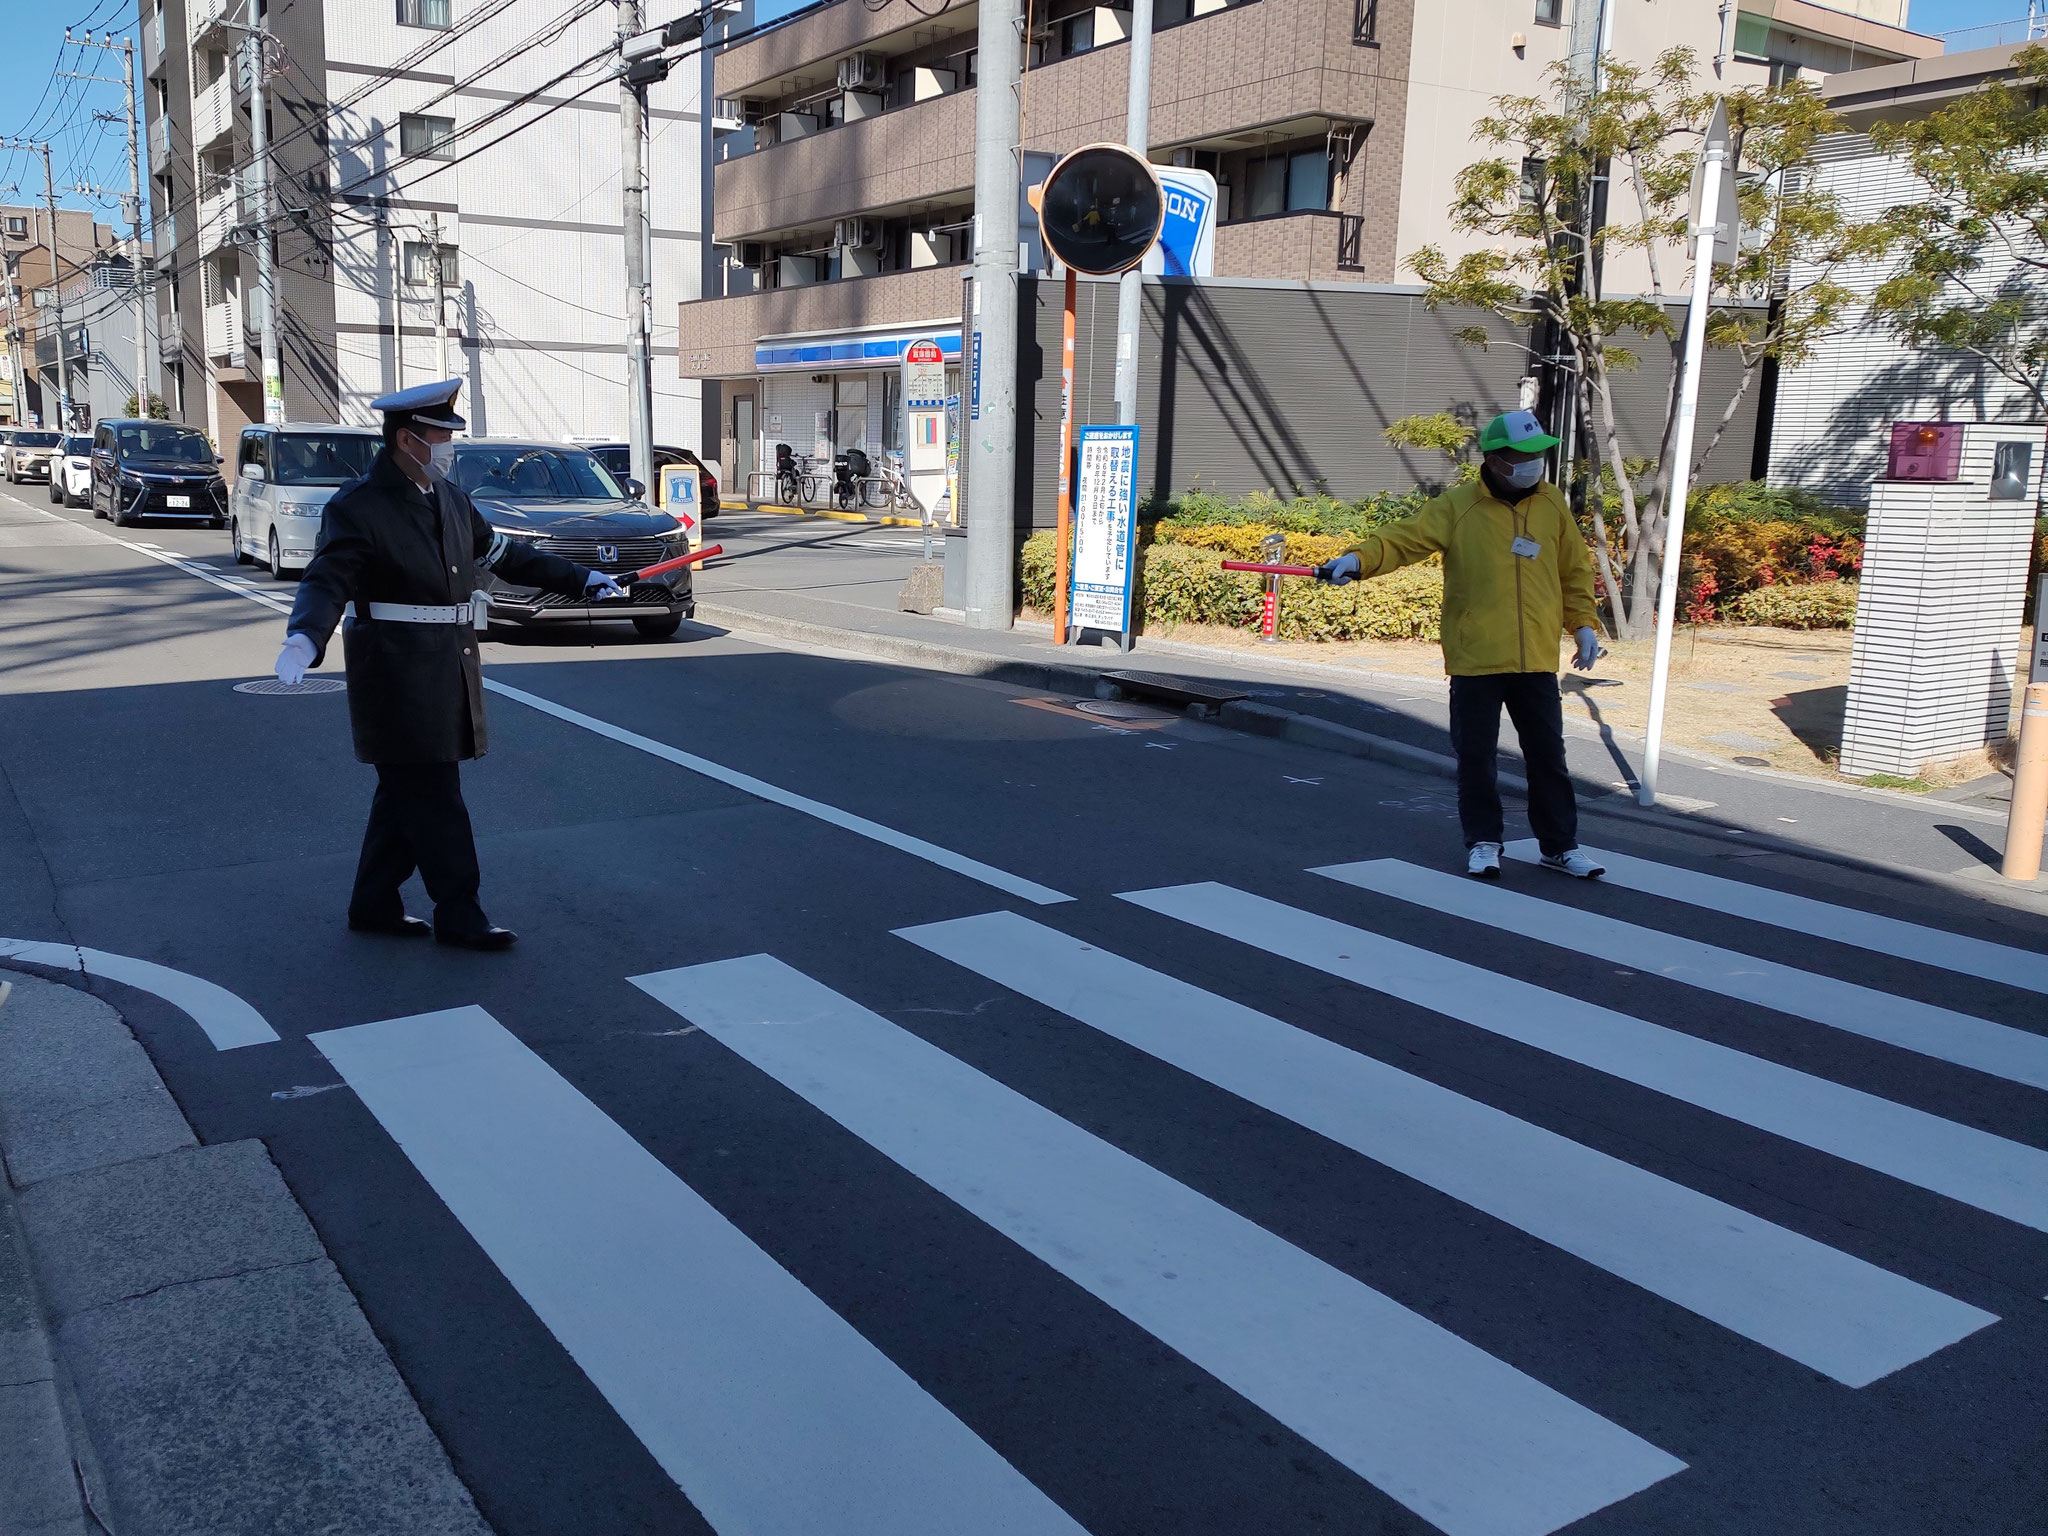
[698,571,2048,907]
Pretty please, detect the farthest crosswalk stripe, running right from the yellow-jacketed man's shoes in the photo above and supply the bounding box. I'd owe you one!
[1507,838,2048,993]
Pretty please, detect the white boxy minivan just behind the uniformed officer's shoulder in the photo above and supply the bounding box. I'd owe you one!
[227,422,383,582]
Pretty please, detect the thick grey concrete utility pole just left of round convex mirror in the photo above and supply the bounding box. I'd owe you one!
[963,0,1024,629]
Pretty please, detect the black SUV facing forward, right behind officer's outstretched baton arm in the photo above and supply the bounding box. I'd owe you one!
[451,438,696,639]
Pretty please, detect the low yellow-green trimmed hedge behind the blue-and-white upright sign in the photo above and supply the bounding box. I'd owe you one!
[1022,532,1444,641]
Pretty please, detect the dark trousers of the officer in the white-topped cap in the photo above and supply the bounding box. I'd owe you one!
[348,762,489,934]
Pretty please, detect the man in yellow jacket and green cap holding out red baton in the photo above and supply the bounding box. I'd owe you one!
[1315,412,1606,881]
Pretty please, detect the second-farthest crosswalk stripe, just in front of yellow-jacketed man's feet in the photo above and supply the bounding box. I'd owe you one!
[1313,858,2048,1087]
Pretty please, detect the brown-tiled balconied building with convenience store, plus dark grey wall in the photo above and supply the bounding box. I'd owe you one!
[680,0,1939,512]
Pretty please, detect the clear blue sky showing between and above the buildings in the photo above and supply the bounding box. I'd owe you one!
[0,0,2025,221]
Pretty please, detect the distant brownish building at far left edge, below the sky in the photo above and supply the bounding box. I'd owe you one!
[0,203,127,424]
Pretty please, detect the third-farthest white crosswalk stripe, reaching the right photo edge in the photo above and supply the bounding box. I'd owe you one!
[1124,883,2048,1231]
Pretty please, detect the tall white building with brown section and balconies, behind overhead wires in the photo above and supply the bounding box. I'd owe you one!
[141,0,709,460]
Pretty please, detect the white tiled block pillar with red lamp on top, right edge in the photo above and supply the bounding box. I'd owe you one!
[1839,422,2048,778]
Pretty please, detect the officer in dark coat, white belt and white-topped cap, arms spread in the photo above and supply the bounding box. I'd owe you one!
[276,379,625,950]
